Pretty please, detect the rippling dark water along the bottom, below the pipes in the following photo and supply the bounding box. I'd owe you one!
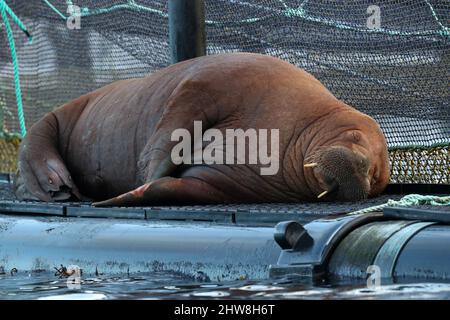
[0,272,450,300]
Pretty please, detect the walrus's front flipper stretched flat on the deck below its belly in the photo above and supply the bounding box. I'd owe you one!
[92,177,231,207]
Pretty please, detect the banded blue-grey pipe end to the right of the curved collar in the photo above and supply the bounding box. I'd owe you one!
[328,220,450,283]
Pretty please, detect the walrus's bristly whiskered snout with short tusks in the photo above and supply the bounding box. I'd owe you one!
[304,146,371,201]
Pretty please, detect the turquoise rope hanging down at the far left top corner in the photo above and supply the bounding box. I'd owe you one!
[0,0,32,137]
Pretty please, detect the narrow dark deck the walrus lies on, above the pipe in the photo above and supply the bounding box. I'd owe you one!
[0,182,408,226]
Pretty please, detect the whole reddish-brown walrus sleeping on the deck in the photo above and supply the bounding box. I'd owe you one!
[15,53,389,205]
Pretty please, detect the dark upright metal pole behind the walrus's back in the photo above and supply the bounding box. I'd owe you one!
[169,0,206,63]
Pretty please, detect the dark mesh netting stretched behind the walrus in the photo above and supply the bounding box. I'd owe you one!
[0,0,450,183]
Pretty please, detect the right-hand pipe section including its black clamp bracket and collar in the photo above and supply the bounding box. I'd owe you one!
[270,211,450,283]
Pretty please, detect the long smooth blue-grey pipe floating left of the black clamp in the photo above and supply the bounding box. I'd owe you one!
[0,215,280,281]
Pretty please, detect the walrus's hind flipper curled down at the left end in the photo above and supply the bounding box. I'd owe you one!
[14,99,85,201]
